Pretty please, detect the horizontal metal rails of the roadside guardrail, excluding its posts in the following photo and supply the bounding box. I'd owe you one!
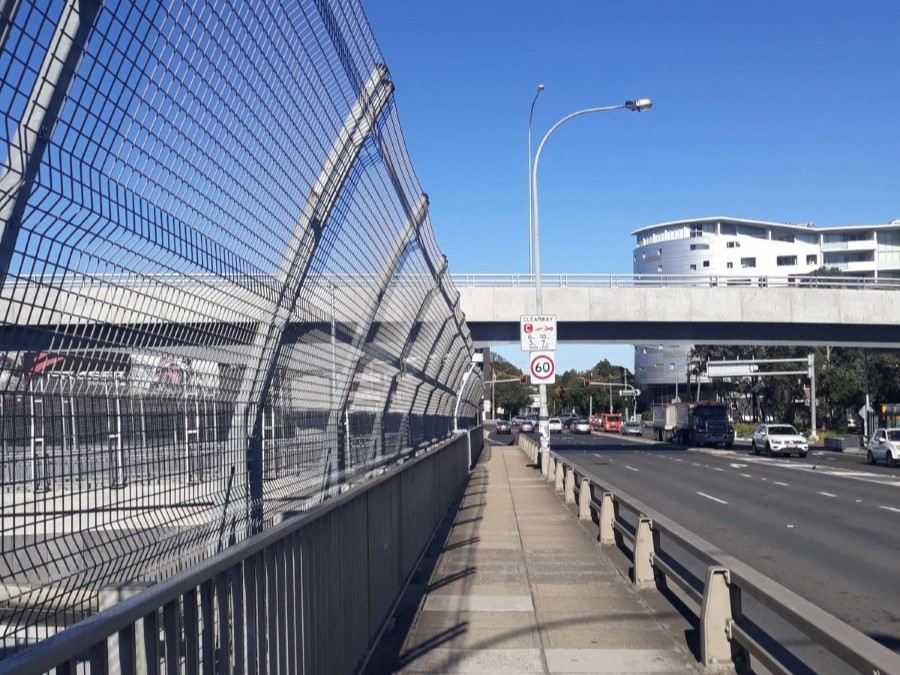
[520,436,900,673]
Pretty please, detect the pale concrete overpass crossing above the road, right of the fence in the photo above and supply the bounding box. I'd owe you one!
[453,274,900,348]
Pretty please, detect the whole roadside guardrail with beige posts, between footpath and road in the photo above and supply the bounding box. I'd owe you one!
[519,434,900,675]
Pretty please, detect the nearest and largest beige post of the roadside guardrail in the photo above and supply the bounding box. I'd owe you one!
[700,566,741,666]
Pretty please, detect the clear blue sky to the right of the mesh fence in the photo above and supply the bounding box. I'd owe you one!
[363,0,900,370]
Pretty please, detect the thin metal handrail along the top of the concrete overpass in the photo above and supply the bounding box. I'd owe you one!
[450,273,900,290]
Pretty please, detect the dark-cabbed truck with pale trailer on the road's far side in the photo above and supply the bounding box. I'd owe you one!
[653,401,734,448]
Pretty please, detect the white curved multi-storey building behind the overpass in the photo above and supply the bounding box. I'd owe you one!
[632,216,900,400]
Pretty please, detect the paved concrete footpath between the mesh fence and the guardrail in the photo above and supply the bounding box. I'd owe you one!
[384,445,700,675]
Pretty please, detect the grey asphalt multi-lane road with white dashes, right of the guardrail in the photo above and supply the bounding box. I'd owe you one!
[528,434,900,652]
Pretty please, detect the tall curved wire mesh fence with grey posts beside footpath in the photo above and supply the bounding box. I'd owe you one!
[0,0,481,647]
